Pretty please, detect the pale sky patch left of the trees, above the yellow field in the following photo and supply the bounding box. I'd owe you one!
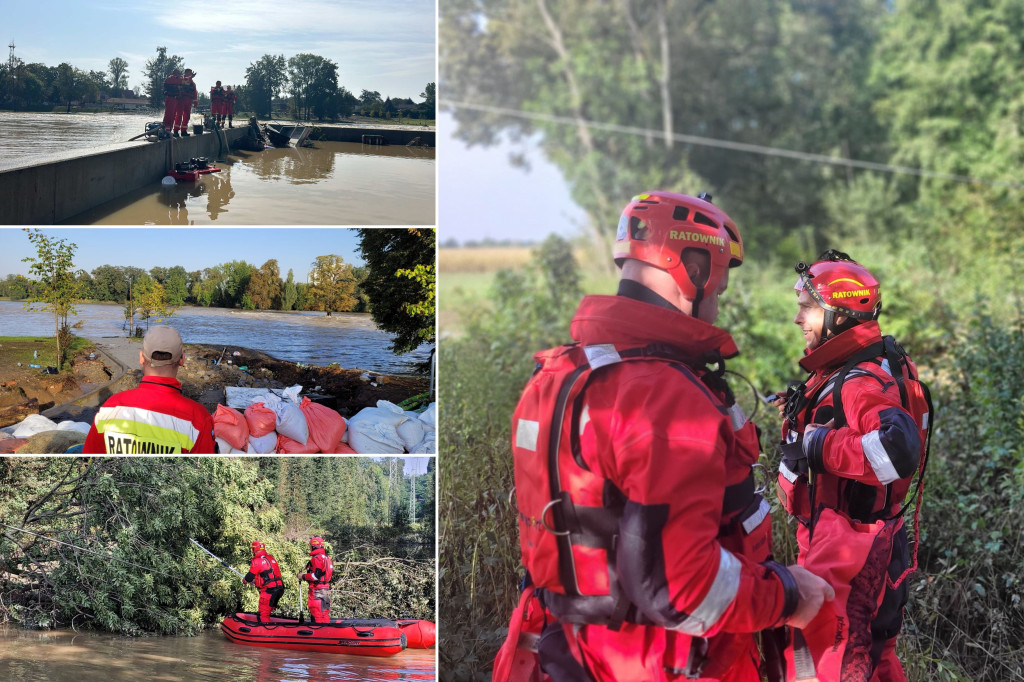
[437,112,586,244]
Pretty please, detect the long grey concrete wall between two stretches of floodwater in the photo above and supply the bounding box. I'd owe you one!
[0,128,246,225]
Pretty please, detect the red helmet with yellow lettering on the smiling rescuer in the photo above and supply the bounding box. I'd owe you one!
[793,249,882,338]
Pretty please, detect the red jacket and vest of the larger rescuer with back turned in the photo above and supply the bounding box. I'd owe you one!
[512,296,796,665]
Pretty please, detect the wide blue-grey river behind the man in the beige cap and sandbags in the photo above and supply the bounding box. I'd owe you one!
[0,301,430,374]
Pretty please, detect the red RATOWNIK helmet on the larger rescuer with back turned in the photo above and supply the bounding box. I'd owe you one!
[614,191,743,301]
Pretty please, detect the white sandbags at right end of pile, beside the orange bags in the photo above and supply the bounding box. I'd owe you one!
[345,400,437,455]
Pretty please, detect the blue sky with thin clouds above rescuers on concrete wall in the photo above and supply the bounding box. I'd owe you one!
[9,0,437,101]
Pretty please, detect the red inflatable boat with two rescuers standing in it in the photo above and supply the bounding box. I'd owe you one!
[220,613,406,656]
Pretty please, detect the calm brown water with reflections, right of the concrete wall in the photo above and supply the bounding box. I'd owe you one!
[66,141,435,225]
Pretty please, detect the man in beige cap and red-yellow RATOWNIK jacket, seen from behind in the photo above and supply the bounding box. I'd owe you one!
[82,325,214,455]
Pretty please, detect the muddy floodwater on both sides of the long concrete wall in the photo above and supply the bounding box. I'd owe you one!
[0,112,436,225]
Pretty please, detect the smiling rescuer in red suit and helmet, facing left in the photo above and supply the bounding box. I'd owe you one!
[776,250,934,682]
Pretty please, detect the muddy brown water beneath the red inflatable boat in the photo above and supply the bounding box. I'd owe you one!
[0,626,436,682]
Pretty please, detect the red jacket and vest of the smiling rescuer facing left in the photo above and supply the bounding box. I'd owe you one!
[778,322,930,525]
